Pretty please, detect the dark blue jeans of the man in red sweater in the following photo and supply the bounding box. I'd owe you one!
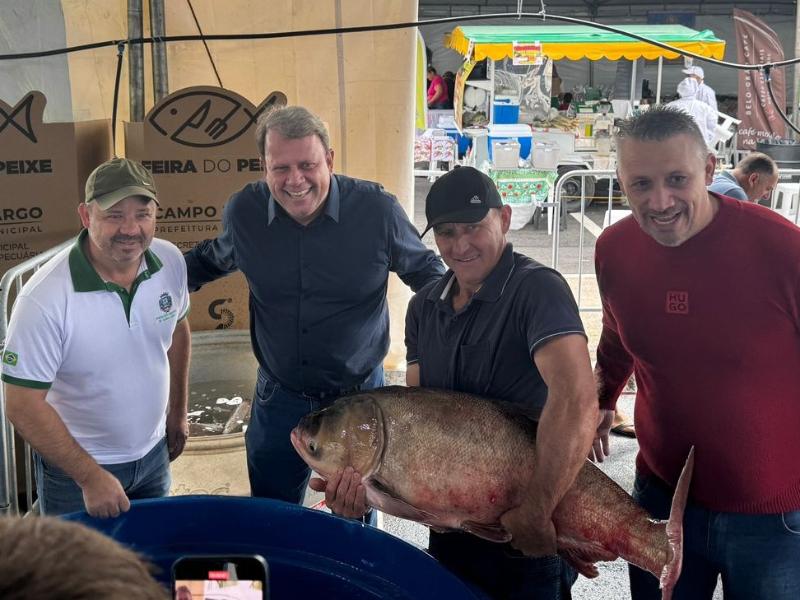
[628,474,800,600]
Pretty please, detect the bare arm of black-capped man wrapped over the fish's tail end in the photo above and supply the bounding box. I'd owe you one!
[501,334,598,556]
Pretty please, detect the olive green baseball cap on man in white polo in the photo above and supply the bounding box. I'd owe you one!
[85,158,158,210]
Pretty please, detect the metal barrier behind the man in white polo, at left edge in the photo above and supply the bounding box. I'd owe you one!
[0,238,75,516]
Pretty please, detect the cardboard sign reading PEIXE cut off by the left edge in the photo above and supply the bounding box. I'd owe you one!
[0,91,111,275]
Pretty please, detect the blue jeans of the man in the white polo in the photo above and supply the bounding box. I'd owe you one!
[33,438,171,515]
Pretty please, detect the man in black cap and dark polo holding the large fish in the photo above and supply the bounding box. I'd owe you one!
[406,167,598,599]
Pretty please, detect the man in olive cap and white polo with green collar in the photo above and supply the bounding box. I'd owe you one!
[2,158,191,517]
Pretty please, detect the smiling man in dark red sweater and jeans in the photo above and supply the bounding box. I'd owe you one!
[595,108,800,600]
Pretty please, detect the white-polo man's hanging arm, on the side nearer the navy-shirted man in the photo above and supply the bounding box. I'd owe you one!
[167,317,192,461]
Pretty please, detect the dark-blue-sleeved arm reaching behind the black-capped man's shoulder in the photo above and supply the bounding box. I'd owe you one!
[390,198,445,292]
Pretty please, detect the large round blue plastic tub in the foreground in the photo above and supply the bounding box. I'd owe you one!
[65,496,483,600]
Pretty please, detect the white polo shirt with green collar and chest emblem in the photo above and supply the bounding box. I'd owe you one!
[0,230,189,464]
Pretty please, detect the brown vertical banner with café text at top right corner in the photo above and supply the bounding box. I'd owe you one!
[733,8,786,150]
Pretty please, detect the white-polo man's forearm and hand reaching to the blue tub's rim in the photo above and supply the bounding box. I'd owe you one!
[5,383,130,517]
